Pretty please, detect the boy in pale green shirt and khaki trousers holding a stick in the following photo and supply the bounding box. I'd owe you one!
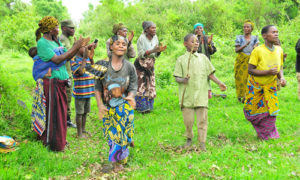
[174,34,227,151]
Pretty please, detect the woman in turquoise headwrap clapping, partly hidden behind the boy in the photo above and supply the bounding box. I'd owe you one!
[194,23,217,60]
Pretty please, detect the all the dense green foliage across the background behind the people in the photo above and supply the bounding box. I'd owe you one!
[0,0,300,70]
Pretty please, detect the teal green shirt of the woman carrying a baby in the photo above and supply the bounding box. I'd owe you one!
[37,37,69,80]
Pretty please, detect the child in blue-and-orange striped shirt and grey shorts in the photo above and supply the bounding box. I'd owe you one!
[71,47,95,138]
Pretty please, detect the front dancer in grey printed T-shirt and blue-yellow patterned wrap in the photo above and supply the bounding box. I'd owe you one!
[95,35,137,171]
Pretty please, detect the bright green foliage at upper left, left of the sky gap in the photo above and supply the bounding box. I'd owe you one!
[0,0,70,51]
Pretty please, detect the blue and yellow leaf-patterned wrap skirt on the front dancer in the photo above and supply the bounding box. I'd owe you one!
[103,101,134,162]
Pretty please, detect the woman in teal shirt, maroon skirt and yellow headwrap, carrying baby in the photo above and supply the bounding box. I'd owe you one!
[33,16,86,151]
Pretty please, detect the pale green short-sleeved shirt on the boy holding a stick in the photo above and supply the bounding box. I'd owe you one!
[173,52,215,108]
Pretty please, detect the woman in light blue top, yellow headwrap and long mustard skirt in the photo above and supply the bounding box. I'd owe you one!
[234,20,259,102]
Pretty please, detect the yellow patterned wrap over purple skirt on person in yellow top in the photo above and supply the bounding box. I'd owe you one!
[244,76,279,140]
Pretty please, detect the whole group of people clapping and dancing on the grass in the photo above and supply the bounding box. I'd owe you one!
[29,16,300,170]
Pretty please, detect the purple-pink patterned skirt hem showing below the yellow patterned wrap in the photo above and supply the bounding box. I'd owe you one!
[244,111,279,140]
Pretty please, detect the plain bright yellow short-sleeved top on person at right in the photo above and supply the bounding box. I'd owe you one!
[249,44,283,85]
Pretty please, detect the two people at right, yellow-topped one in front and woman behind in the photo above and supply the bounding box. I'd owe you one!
[234,20,286,140]
